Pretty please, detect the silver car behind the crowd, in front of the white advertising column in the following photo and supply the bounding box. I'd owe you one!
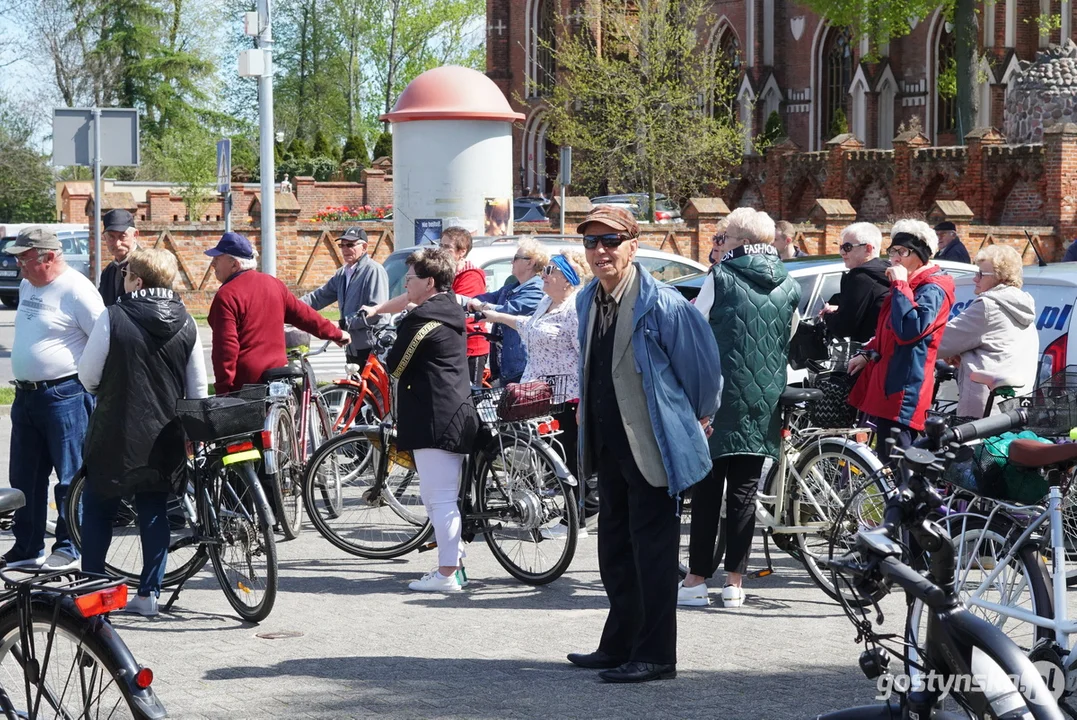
[382,235,707,297]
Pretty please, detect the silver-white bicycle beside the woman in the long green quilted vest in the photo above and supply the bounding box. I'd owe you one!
[680,385,890,602]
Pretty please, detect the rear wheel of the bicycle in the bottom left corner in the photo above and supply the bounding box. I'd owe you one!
[0,602,152,720]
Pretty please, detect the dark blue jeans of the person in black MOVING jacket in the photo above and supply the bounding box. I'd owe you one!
[82,486,171,597]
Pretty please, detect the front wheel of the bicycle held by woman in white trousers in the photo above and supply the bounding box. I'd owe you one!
[303,429,433,560]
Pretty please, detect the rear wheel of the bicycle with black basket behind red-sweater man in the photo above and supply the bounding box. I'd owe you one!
[201,463,277,622]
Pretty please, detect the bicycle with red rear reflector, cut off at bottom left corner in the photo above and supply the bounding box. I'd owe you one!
[0,489,167,720]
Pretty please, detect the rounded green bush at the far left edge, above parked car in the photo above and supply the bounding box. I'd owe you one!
[0,101,56,223]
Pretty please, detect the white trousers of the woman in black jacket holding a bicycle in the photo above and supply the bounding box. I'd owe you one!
[411,448,464,567]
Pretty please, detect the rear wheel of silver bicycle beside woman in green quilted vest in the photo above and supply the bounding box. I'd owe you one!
[784,438,890,605]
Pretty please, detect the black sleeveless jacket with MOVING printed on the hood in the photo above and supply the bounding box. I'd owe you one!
[83,288,197,497]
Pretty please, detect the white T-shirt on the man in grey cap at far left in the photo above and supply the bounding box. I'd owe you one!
[11,268,104,382]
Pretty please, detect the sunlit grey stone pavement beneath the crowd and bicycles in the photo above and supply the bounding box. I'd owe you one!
[0,408,1068,720]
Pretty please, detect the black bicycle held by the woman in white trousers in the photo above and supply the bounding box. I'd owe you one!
[307,376,578,585]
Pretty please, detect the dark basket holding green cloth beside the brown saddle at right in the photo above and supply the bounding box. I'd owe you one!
[942,430,1048,505]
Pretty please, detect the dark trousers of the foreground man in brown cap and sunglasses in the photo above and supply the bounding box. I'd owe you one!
[598,446,681,664]
